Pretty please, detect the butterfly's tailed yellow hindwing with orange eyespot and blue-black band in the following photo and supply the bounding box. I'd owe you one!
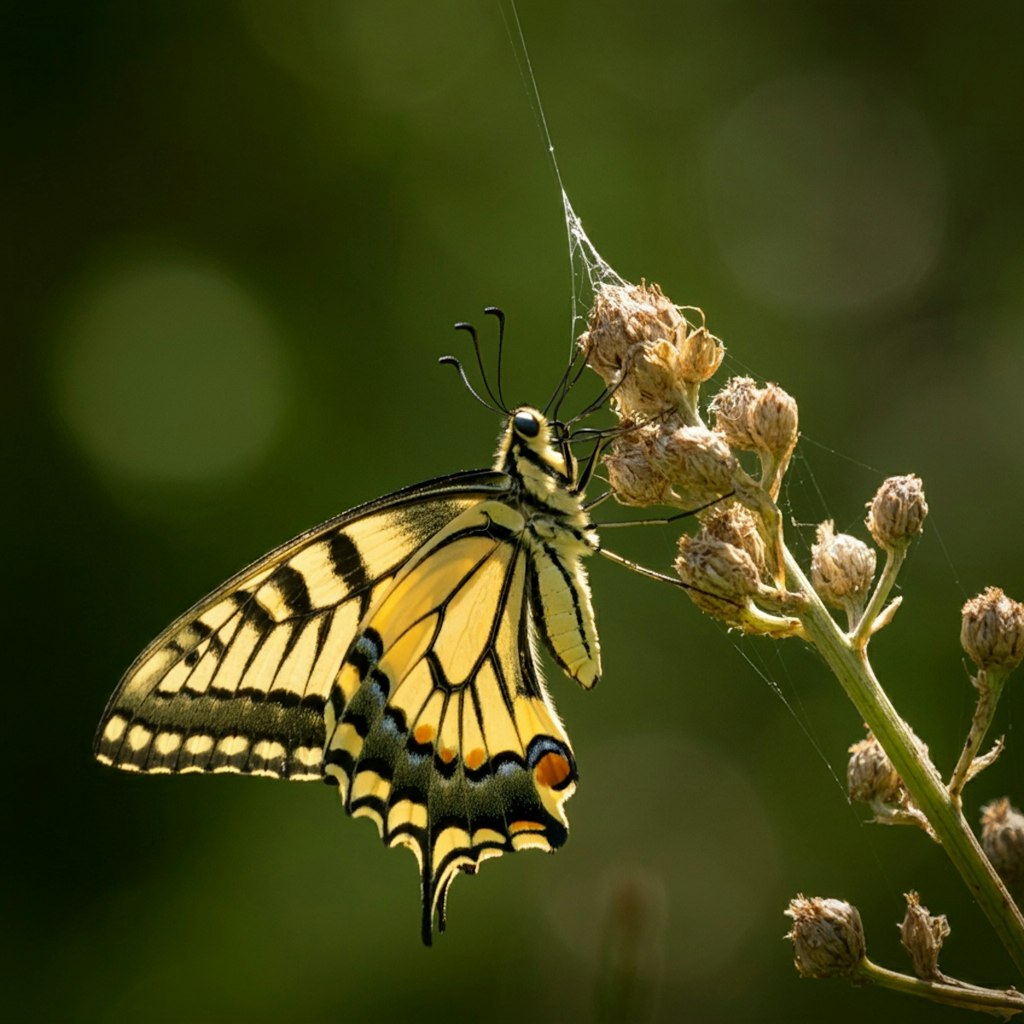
[324,501,577,942]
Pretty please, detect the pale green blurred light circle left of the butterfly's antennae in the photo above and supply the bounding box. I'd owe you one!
[52,253,288,482]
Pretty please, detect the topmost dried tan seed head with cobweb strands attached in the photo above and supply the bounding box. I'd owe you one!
[580,282,712,417]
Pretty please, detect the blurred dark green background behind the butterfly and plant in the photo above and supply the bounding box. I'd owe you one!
[8,0,1024,1024]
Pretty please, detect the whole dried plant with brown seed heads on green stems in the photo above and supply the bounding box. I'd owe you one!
[580,284,1024,1013]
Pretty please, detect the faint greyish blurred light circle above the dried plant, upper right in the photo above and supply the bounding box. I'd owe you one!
[707,73,946,312]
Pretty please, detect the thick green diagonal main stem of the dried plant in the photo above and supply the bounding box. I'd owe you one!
[784,549,1024,974]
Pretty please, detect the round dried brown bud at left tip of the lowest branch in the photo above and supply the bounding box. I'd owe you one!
[785,896,866,978]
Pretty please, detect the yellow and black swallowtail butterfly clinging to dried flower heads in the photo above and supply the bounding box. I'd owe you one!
[95,309,614,945]
